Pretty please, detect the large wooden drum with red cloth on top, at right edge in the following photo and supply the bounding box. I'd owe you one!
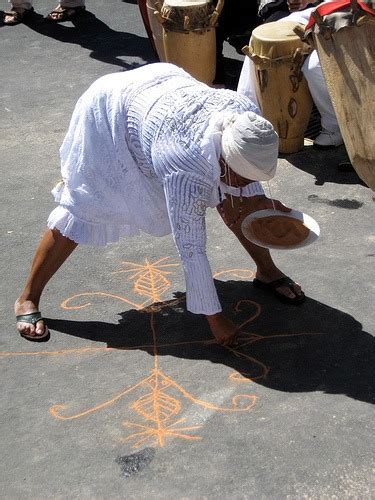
[306,0,375,191]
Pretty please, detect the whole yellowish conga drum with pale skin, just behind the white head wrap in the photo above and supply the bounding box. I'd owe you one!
[242,21,313,153]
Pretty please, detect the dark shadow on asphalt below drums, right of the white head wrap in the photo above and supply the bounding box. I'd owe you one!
[280,146,367,187]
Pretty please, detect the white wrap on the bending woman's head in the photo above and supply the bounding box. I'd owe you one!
[221,111,279,181]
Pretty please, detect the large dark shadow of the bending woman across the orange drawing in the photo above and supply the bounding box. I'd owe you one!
[47,281,375,403]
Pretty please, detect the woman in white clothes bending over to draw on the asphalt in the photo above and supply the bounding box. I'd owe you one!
[15,63,304,344]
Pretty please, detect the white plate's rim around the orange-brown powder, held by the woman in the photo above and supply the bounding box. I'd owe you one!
[241,209,320,250]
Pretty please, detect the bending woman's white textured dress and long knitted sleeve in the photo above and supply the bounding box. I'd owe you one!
[48,63,263,314]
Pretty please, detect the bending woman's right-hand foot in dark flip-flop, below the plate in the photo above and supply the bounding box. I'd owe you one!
[254,267,305,304]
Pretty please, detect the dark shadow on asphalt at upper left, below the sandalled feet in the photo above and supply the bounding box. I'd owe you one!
[19,10,157,69]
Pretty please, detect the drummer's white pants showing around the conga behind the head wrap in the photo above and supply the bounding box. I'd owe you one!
[241,8,340,132]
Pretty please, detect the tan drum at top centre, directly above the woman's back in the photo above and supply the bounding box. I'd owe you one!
[161,0,223,83]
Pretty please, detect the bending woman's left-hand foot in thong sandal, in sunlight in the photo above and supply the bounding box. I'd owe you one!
[14,299,49,342]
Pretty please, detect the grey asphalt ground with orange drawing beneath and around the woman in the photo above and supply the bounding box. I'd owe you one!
[0,0,375,500]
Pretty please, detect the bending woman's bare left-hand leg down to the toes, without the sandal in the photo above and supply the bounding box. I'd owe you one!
[14,229,77,337]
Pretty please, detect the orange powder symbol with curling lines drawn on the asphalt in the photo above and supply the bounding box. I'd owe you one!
[0,257,326,448]
